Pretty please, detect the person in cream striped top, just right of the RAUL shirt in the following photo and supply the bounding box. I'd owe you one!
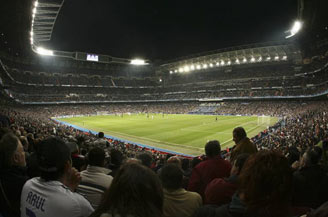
[77,147,113,208]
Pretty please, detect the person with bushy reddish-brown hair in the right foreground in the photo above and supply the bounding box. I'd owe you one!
[194,150,292,217]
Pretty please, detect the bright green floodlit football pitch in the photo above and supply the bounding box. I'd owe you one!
[57,114,278,155]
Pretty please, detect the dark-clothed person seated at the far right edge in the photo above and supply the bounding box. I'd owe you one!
[293,148,328,208]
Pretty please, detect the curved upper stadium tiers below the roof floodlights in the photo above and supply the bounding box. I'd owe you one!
[0,40,328,103]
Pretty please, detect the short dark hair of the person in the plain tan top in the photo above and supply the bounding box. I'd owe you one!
[159,163,183,190]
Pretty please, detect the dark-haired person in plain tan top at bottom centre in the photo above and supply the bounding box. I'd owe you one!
[160,163,202,217]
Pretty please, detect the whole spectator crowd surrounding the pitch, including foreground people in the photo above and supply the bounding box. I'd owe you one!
[0,101,328,217]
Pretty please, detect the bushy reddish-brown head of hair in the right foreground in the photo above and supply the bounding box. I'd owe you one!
[239,150,292,217]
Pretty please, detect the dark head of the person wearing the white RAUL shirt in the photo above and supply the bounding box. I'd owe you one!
[37,137,72,181]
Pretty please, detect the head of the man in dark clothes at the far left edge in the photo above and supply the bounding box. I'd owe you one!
[0,133,26,169]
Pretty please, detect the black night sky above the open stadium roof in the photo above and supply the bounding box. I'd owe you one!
[44,0,297,61]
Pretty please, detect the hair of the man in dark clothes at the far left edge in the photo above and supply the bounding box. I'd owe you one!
[0,133,19,169]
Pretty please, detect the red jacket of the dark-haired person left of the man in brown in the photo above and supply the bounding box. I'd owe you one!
[188,156,231,199]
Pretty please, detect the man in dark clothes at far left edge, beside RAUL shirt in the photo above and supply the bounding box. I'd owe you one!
[0,133,27,217]
